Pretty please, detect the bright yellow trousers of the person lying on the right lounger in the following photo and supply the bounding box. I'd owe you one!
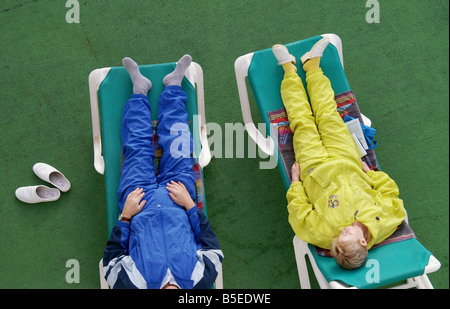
[281,67,361,180]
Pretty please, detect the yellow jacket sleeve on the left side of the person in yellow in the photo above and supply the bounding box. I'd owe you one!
[286,181,335,249]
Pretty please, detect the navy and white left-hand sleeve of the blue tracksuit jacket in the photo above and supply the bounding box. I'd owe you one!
[103,221,147,289]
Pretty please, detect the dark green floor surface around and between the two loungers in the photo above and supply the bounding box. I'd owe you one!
[0,0,449,289]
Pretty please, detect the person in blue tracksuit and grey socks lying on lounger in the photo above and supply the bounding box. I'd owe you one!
[103,55,223,289]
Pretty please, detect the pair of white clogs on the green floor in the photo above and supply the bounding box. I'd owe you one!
[16,163,70,204]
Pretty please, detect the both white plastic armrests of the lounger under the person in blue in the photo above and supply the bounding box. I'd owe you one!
[89,62,211,174]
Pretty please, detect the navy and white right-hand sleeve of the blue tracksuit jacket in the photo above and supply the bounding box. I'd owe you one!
[187,206,223,289]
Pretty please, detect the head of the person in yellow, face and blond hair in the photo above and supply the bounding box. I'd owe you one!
[331,225,368,269]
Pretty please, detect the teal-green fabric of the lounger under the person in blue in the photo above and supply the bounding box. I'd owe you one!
[98,63,202,235]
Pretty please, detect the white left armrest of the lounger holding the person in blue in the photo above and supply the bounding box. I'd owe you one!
[89,68,111,174]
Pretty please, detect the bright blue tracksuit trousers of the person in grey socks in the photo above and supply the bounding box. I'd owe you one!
[118,86,195,210]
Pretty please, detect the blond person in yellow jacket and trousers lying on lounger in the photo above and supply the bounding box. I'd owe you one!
[272,37,406,269]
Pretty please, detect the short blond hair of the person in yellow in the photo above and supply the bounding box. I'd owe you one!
[331,238,368,269]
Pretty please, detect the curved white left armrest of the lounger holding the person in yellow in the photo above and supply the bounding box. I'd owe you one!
[234,53,275,156]
